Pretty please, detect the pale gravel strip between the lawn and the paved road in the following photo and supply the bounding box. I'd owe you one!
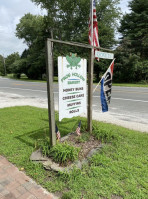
[0,92,148,133]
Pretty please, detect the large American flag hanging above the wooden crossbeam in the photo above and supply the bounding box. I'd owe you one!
[89,0,100,59]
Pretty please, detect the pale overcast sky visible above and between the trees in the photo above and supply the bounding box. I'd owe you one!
[0,0,129,57]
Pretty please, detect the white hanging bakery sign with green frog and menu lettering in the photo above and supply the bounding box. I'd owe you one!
[58,54,87,121]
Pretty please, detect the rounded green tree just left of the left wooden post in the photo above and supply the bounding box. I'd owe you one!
[14,13,46,79]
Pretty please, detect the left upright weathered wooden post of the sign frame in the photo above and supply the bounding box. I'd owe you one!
[46,39,56,146]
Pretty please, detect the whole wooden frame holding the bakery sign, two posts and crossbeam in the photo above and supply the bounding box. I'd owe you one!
[46,39,111,146]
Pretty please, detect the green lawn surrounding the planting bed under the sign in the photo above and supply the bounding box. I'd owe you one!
[0,106,148,199]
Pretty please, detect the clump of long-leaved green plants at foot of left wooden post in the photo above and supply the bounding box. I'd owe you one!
[48,142,80,163]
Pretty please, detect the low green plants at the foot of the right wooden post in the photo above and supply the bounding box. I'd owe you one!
[93,123,119,143]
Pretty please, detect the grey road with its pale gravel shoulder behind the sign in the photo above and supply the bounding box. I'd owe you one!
[0,77,148,132]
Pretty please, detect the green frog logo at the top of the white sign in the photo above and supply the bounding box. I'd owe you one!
[66,53,81,70]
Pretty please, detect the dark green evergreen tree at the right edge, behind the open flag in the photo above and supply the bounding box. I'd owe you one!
[114,0,148,82]
